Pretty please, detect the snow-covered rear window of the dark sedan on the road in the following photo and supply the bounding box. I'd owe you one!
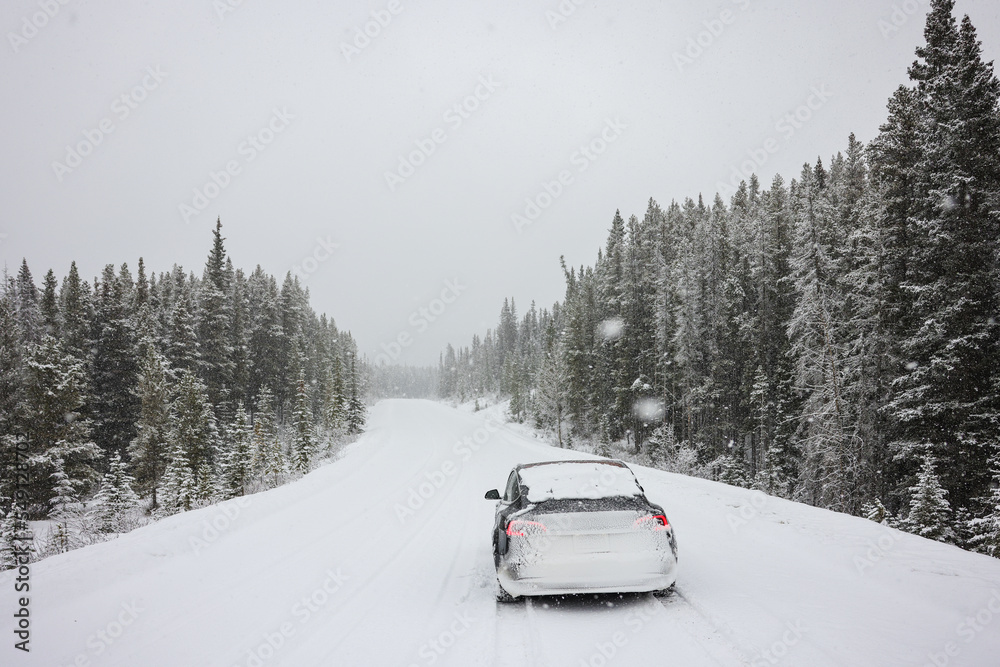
[521,461,642,503]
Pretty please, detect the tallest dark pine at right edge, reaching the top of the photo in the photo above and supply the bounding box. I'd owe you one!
[888,0,1000,506]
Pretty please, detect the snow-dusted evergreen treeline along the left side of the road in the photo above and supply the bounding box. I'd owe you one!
[0,222,365,560]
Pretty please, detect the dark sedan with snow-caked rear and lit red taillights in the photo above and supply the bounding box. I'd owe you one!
[486,459,677,602]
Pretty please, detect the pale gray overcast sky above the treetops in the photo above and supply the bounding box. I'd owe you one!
[0,0,1000,364]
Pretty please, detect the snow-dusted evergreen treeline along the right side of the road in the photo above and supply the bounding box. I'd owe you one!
[441,0,1000,555]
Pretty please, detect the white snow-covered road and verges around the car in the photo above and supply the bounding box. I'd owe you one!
[0,400,1000,667]
